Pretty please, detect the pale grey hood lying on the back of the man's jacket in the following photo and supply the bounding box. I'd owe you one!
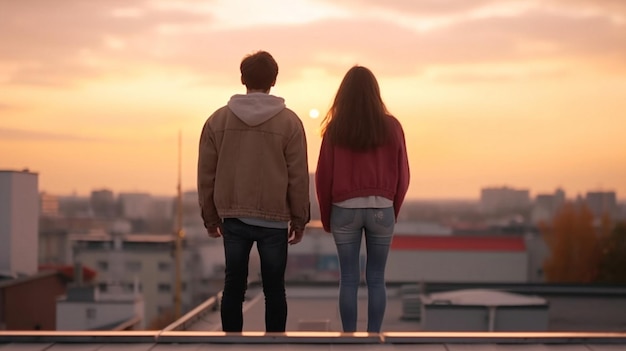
[228,93,286,127]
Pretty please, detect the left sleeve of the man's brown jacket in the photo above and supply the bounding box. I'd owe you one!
[198,120,221,228]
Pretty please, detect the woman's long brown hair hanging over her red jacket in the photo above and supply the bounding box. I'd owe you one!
[322,66,389,151]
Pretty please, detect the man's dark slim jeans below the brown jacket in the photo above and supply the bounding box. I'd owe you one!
[221,218,288,332]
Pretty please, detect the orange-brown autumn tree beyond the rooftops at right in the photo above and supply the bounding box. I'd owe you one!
[540,202,602,283]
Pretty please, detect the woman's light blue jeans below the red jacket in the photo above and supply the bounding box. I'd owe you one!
[330,206,395,333]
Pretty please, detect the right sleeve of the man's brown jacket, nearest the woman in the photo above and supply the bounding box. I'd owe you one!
[285,120,311,230]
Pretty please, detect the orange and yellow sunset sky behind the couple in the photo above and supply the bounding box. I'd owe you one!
[0,0,626,199]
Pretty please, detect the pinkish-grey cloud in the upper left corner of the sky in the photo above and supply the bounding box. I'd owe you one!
[0,0,210,85]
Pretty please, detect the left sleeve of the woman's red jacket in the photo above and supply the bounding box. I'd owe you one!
[315,137,334,233]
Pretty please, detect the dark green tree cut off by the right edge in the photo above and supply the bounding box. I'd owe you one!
[598,222,626,284]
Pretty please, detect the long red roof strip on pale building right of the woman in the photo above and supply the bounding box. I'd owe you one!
[391,235,526,251]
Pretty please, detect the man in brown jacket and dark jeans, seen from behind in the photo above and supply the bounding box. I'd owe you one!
[198,51,310,332]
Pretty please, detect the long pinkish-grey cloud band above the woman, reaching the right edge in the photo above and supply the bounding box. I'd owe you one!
[260,11,626,79]
